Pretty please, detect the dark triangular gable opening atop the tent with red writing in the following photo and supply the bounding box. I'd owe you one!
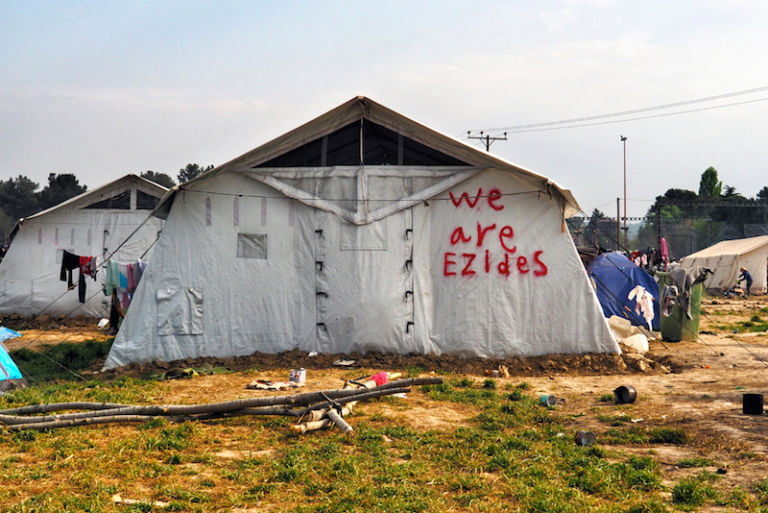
[257,118,468,167]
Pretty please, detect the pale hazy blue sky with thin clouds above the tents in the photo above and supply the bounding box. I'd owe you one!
[0,0,768,216]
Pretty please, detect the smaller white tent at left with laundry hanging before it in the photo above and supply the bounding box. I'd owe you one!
[0,175,167,317]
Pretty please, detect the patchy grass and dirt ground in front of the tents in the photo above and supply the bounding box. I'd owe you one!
[0,297,768,512]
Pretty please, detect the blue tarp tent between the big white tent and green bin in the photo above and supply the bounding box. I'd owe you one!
[587,253,659,331]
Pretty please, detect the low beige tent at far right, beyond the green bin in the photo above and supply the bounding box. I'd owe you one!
[680,235,768,294]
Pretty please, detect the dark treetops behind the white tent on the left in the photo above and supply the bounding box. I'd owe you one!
[0,164,213,242]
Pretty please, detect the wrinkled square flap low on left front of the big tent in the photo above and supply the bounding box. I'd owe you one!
[157,288,203,336]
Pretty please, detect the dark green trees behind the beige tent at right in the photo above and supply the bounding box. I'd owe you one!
[569,167,768,256]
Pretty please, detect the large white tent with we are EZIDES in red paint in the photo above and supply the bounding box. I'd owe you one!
[105,97,619,368]
